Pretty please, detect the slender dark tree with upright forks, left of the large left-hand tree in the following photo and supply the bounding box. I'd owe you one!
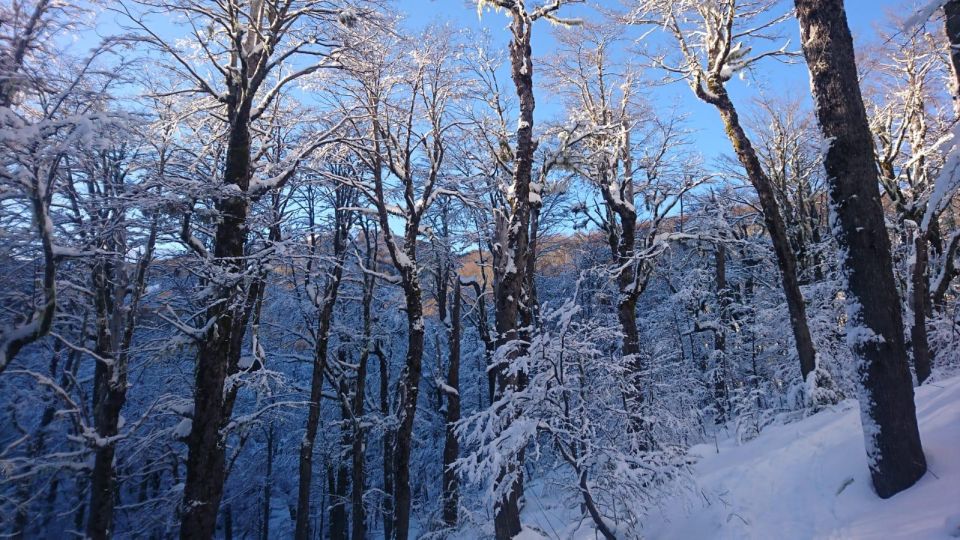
[74,145,164,539]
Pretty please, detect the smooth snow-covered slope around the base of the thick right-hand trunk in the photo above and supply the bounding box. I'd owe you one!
[524,377,960,540]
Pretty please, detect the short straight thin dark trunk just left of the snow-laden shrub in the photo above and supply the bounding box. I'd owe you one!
[443,280,461,527]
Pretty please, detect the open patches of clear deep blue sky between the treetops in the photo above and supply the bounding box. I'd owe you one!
[397,0,914,159]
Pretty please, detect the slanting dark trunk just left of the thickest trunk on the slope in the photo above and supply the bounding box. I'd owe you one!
[697,82,817,380]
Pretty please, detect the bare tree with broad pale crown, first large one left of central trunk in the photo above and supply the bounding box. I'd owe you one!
[330,25,463,540]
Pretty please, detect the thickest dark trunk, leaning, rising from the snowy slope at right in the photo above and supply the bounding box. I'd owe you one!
[795,0,927,498]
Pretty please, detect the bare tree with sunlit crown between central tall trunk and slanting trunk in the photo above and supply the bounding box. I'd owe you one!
[545,26,702,436]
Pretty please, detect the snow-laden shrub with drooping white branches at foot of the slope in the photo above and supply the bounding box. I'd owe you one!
[456,286,688,537]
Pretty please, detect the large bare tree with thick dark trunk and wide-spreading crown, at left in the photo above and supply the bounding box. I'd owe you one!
[116,0,358,538]
